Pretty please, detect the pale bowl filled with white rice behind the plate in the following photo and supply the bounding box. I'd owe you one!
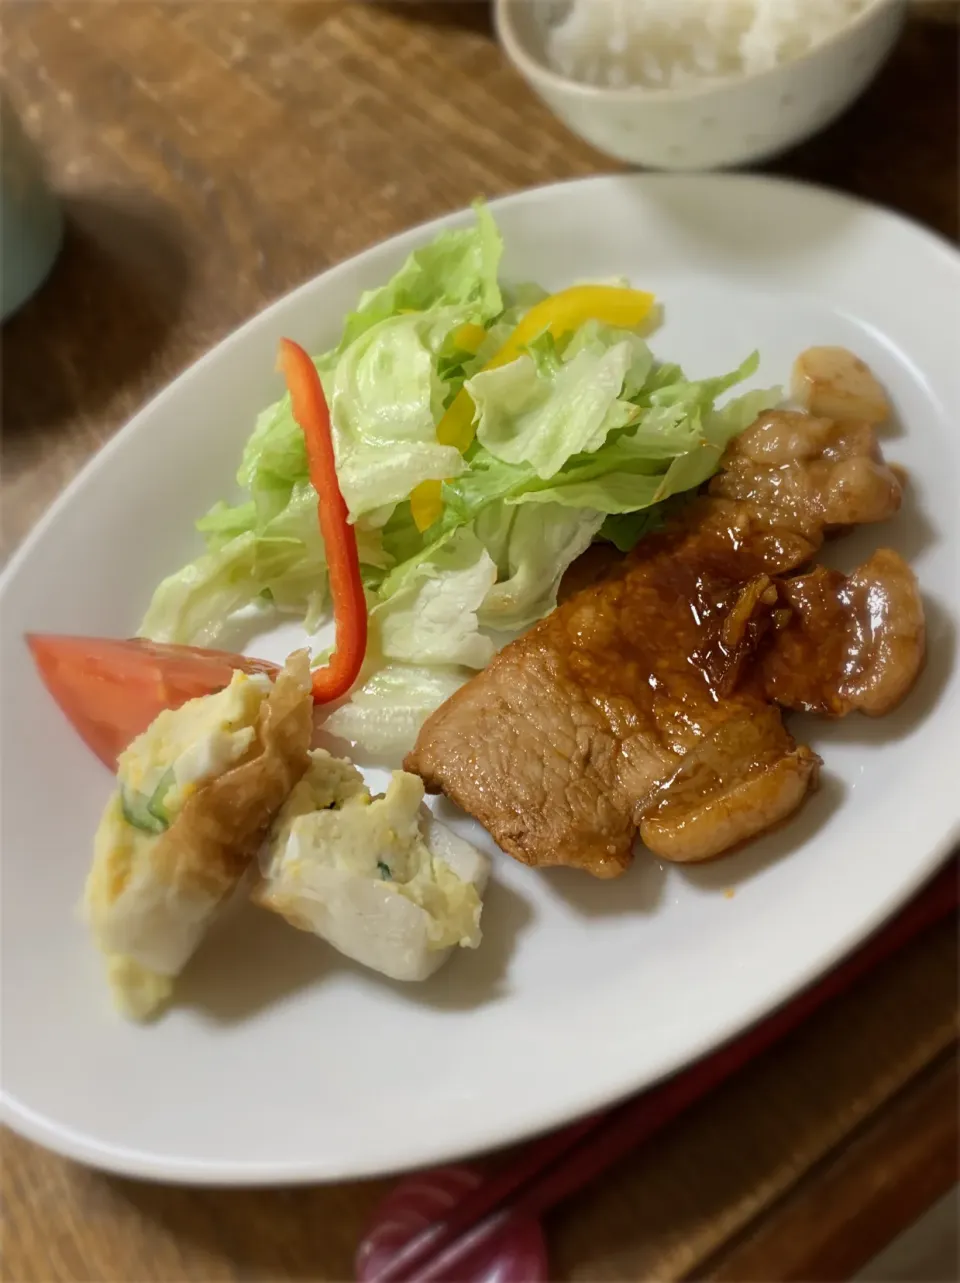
[494,0,906,169]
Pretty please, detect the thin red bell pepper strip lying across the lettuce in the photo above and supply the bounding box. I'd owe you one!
[279,339,367,704]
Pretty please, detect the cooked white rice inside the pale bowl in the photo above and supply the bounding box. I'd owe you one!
[547,0,886,89]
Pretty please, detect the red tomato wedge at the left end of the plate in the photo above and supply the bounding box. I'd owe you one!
[27,633,279,771]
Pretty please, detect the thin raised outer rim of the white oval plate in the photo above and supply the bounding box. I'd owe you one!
[0,172,960,1187]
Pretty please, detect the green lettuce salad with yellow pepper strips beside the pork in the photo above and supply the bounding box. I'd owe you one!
[141,205,782,753]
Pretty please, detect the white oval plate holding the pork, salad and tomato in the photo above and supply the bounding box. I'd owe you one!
[0,176,960,1184]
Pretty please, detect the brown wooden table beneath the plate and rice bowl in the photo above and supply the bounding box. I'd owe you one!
[3,0,957,1283]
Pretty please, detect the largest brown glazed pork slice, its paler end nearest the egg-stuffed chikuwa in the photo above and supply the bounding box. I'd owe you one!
[407,513,818,878]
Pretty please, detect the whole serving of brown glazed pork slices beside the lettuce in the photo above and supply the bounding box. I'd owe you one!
[406,412,923,876]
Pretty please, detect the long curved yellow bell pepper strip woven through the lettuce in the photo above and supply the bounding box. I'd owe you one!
[409,285,656,532]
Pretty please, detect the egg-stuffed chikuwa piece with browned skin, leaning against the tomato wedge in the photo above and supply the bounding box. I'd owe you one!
[83,650,313,1019]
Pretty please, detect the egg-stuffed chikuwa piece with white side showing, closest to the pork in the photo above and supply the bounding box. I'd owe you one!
[252,749,490,980]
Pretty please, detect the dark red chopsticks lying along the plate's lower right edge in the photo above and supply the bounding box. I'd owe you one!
[370,860,960,1283]
